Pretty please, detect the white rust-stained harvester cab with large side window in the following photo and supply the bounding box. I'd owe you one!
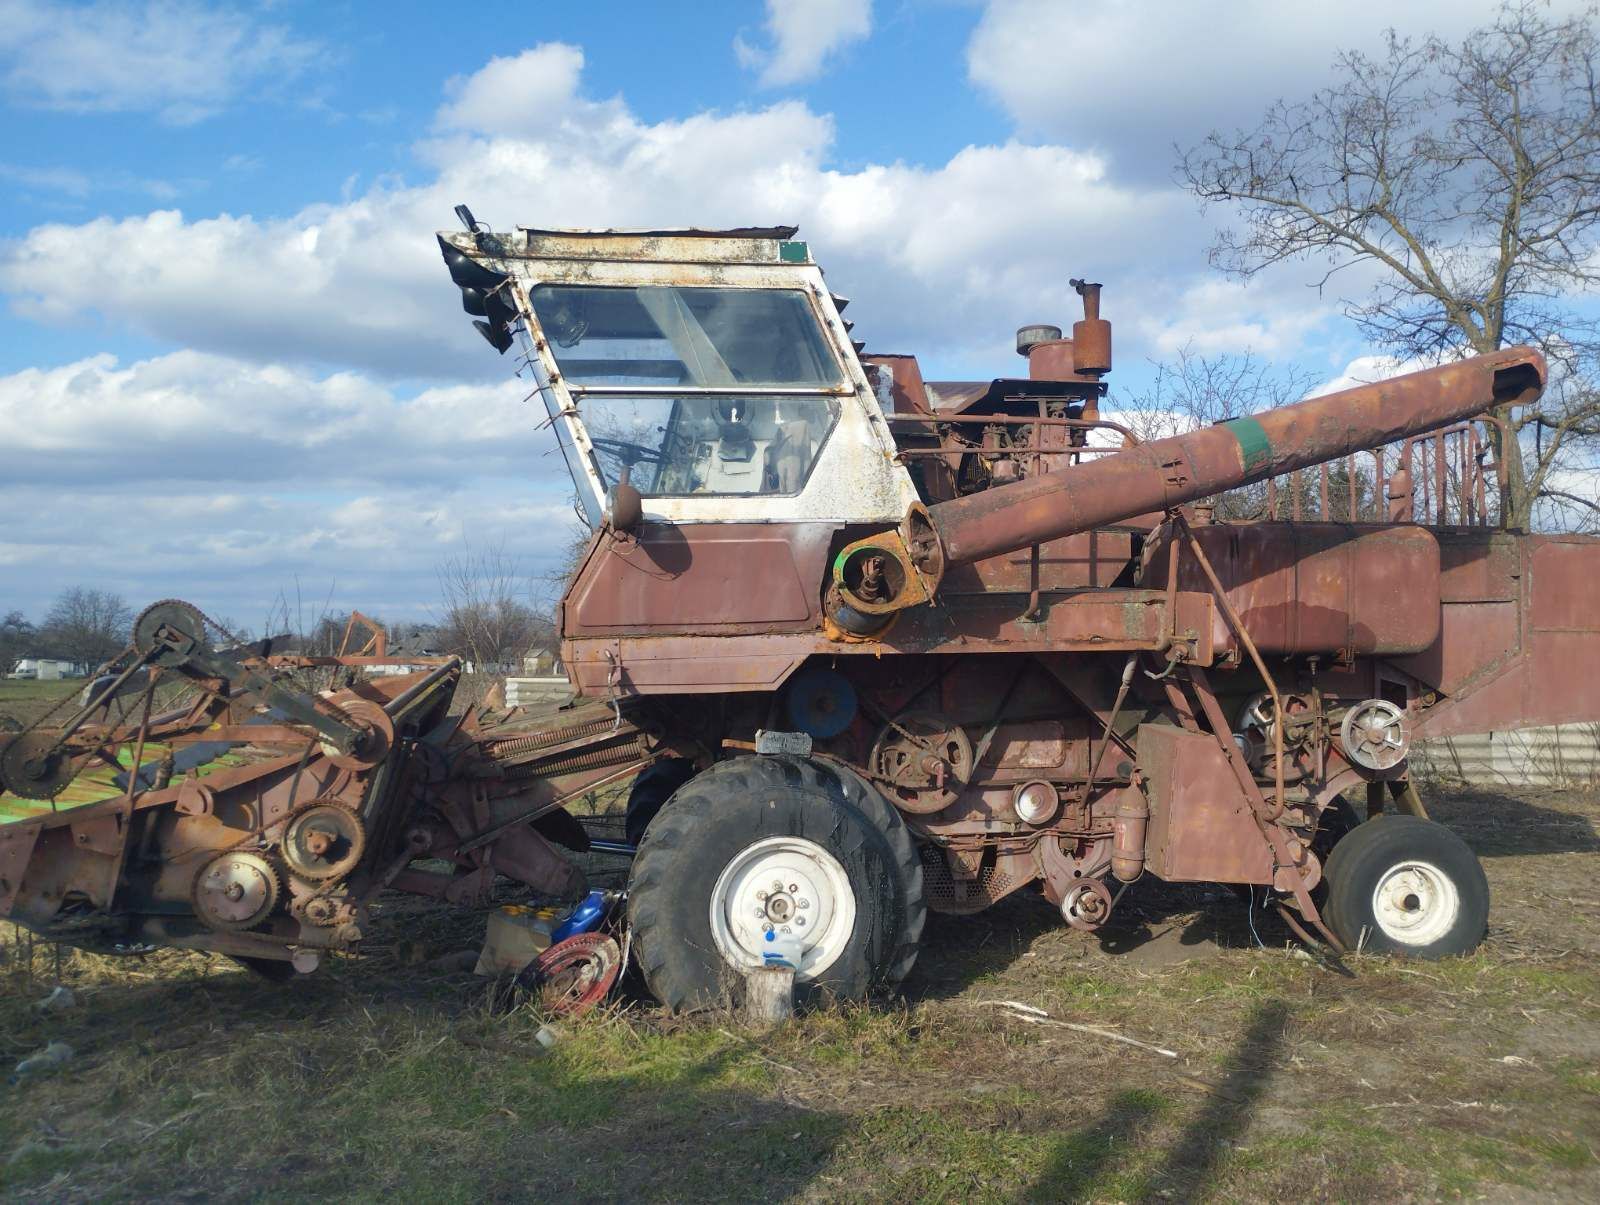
[440,217,915,528]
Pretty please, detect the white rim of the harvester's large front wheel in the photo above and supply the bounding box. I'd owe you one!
[710,837,856,983]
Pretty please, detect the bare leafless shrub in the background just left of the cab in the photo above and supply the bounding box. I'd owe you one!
[438,544,554,672]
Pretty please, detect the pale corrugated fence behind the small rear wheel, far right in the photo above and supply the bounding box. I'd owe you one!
[1411,723,1600,787]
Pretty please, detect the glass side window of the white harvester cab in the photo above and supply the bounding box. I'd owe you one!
[530,285,843,496]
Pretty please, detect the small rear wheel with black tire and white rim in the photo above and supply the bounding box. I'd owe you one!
[1323,816,1490,959]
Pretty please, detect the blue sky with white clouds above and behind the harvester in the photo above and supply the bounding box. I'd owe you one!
[0,0,1574,627]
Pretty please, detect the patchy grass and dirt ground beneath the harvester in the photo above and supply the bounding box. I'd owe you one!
[0,774,1600,1200]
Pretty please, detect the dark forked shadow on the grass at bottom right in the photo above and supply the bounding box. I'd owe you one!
[1024,1000,1290,1200]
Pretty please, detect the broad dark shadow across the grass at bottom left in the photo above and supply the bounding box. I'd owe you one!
[0,963,858,1202]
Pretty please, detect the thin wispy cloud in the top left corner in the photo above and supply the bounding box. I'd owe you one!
[0,0,323,125]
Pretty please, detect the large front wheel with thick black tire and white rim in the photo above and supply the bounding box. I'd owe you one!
[629,757,926,1011]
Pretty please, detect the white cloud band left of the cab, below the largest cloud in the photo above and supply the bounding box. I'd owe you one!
[0,350,555,486]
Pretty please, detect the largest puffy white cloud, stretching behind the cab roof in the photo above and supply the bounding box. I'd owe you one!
[0,45,1253,379]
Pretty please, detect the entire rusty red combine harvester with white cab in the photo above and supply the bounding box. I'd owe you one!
[0,216,1600,1008]
